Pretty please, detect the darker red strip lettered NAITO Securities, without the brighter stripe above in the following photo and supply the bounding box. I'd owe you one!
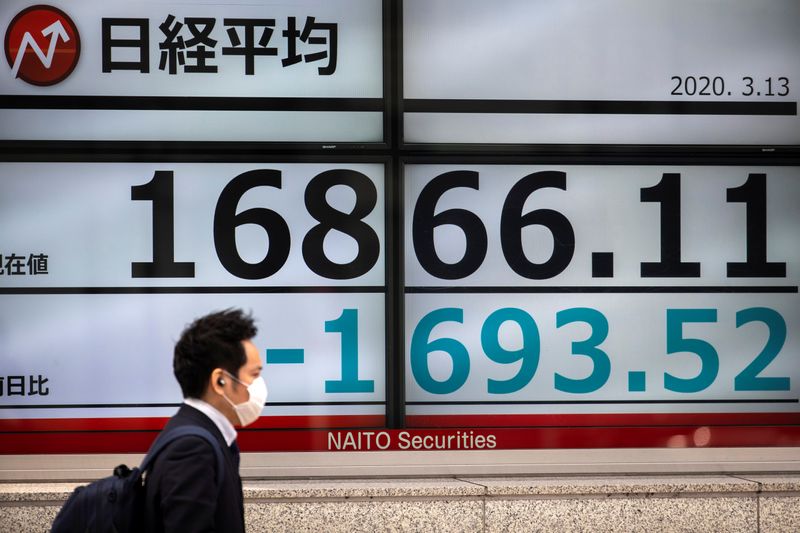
[0,426,800,454]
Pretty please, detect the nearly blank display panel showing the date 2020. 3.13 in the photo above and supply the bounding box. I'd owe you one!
[402,0,800,149]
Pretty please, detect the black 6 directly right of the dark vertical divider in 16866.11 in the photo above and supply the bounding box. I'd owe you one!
[411,170,487,279]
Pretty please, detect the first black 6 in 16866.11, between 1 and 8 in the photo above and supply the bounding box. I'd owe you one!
[214,169,291,279]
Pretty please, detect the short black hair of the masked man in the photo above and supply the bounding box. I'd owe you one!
[172,309,258,398]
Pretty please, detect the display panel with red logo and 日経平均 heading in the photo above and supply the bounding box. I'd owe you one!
[0,0,385,143]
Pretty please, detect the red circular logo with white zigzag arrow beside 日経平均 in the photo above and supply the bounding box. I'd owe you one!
[5,5,81,86]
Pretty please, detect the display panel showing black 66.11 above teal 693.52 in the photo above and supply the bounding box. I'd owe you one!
[404,163,800,447]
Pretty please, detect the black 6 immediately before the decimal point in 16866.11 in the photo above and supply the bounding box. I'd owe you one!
[500,170,575,279]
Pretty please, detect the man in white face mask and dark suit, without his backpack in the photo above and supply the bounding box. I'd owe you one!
[145,309,267,532]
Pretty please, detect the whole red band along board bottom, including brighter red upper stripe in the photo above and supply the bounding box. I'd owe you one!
[0,413,800,454]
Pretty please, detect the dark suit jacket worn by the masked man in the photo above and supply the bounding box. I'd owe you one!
[145,404,244,533]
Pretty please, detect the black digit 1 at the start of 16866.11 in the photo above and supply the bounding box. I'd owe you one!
[131,170,194,278]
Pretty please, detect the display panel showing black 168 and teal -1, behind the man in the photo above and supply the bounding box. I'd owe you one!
[0,162,386,451]
